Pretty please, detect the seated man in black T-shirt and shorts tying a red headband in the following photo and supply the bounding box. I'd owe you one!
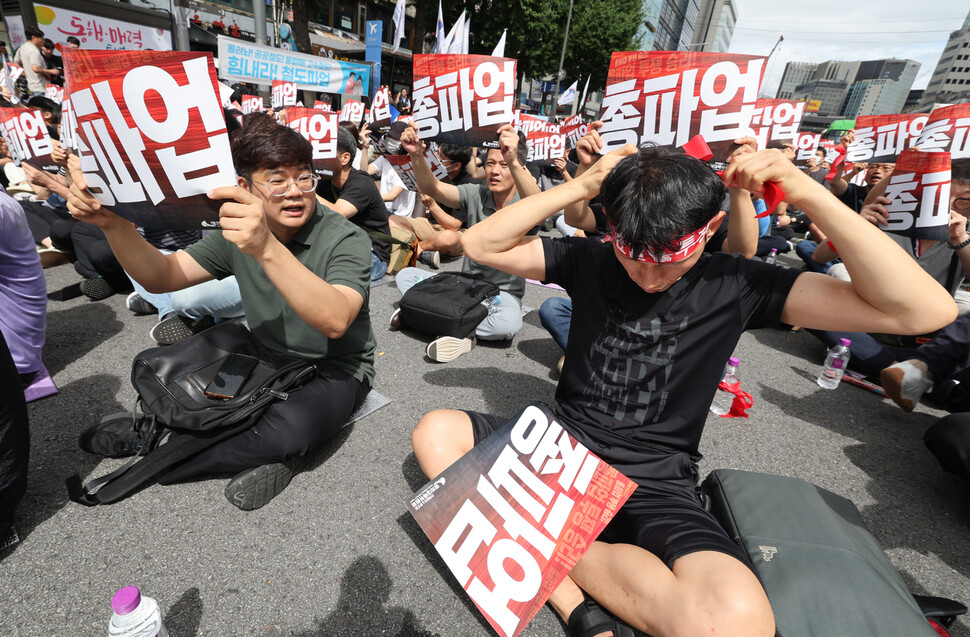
[412,125,956,637]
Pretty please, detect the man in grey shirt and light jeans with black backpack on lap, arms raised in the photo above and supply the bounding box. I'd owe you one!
[391,124,539,363]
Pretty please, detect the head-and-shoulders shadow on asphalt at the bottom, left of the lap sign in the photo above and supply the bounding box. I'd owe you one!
[292,555,435,637]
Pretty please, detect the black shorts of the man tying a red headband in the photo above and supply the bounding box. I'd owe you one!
[465,411,751,569]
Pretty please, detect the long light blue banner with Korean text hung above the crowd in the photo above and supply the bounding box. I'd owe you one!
[219,35,371,95]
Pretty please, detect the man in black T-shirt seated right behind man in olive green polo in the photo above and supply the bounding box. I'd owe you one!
[320,123,391,281]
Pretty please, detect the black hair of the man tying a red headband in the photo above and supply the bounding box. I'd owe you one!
[600,145,724,258]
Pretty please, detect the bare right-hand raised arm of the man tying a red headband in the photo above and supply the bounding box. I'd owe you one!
[724,150,957,334]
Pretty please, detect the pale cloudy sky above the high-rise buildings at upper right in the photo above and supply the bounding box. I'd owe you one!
[731,0,970,95]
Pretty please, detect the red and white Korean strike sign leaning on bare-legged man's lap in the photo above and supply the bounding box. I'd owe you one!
[407,403,636,637]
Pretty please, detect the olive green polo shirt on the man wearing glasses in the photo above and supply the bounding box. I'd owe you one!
[185,203,377,384]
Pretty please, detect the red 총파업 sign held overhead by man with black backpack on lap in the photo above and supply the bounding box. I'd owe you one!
[412,55,516,148]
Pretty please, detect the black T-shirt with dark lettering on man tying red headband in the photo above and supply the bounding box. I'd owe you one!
[542,237,801,480]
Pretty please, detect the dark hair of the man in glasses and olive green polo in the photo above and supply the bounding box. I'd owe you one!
[231,113,313,179]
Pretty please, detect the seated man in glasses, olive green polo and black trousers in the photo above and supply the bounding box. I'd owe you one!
[68,117,376,510]
